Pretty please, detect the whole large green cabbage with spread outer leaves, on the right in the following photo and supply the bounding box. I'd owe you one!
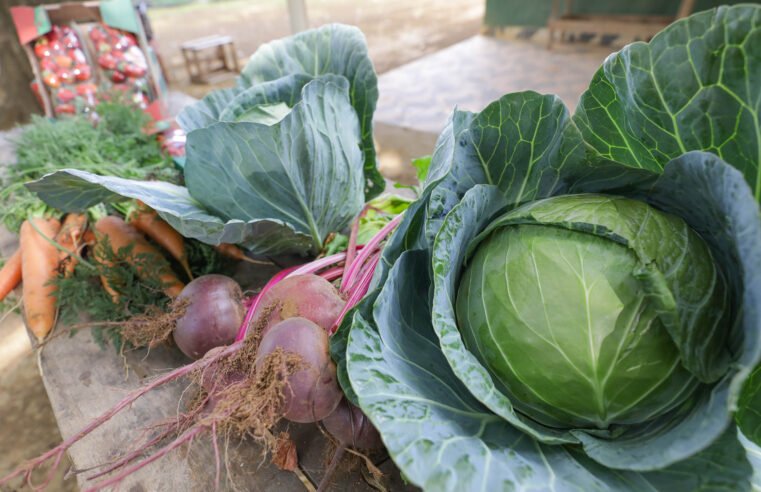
[331,5,761,486]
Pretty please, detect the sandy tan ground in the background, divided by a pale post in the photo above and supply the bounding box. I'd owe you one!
[149,0,484,90]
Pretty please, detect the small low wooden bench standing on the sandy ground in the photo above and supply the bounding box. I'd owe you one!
[180,35,240,84]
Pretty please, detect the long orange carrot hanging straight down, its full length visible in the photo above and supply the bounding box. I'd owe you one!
[19,218,61,341]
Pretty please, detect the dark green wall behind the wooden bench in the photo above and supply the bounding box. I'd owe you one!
[484,0,759,27]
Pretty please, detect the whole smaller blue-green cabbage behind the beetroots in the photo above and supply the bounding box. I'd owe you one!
[30,25,385,255]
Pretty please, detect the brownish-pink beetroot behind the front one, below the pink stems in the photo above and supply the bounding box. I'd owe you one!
[254,275,346,335]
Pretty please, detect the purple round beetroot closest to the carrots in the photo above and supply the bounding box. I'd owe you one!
[174,275,244,359]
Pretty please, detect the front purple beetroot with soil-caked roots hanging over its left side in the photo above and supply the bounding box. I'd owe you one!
[256,318,343,423]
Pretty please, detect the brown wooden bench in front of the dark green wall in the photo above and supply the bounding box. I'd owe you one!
[547,0,695,48]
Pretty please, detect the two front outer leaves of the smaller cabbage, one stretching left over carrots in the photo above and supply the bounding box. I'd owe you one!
[28,75,364,254]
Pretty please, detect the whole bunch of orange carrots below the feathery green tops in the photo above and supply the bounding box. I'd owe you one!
[0,204,255,342]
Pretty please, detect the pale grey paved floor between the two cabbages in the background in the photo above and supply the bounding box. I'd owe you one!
[375,36,610,183]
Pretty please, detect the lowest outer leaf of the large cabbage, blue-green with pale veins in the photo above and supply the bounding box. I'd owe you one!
[347,246,750,492]
